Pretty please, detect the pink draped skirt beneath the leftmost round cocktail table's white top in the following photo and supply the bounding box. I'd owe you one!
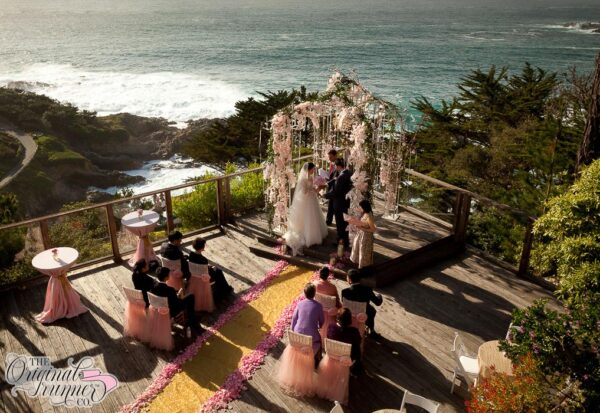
[35,273,88,324]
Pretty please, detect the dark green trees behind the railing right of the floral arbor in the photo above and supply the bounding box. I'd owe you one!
[414,63,591,262]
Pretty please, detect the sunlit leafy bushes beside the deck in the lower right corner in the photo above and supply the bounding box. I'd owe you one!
[469,160,600,413]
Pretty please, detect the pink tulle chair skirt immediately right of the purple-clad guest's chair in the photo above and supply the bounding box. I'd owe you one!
[316,354,352,405]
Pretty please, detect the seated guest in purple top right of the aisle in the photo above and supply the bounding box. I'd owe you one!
[292,283,325,360]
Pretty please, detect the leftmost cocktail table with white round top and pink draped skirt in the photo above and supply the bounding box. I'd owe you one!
[31,247,88,324]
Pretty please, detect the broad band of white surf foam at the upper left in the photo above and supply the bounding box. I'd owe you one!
[0,64,247,126]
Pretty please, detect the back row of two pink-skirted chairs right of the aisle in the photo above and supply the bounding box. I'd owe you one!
[277,330,352,404]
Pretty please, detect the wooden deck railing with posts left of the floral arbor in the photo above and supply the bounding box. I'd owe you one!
[0,155,312,269]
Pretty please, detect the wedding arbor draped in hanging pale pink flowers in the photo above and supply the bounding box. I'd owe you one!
[265,72,413,229]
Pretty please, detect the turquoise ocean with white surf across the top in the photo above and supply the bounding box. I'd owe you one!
[0,0,600,122]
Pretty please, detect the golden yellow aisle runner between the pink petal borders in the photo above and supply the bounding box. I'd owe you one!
[147,265,313,413]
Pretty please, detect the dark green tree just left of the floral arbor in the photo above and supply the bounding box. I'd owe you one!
[184,86,317,164]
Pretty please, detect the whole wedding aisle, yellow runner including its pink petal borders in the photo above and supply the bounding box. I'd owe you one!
[123,262,314,413]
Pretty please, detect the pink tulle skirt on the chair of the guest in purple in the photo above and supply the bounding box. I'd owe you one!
[277,345,315,397]
